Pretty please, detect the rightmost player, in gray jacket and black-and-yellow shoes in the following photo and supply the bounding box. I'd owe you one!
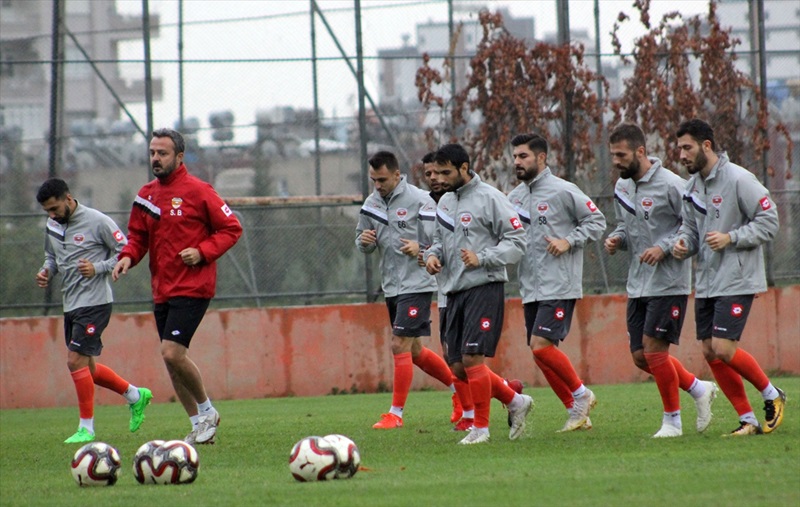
[672,119,786,436]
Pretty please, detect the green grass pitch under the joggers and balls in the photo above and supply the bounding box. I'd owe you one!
[0,377,800,507]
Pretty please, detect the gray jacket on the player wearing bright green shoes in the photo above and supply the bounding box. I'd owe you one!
[41,203,128,313]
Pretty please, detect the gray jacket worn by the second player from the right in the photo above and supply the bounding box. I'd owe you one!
[608,157,692,298]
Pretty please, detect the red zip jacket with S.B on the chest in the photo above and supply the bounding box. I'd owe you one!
[120,164,242,303]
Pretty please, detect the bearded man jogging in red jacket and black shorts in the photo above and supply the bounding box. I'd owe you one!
[111,129,242,445]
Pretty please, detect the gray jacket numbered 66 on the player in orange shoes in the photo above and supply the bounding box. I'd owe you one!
[356,176,436,297]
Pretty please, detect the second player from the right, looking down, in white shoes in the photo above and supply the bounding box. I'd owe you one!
[604,124,717,438]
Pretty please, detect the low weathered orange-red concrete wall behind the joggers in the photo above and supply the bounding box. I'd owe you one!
[0,286,800,409]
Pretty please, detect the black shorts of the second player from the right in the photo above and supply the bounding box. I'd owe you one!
[627,295,689,352]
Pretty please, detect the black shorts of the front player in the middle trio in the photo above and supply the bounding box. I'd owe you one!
[445,282,505,364]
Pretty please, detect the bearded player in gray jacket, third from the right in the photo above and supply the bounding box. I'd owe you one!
[508,134,606,431]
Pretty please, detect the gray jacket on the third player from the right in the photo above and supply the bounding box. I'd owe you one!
[508,167,606,303]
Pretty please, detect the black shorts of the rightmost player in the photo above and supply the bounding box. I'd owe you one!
[694,294,754,341]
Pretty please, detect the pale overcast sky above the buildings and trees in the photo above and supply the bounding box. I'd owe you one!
[117,0,708,141]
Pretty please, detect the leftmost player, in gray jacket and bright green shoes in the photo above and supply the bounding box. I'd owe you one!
[36,178,153,444]
